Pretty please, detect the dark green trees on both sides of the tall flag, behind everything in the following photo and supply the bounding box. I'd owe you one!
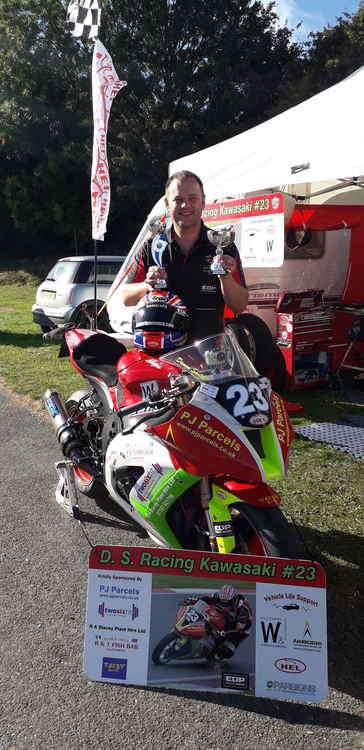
[0,0,300,254]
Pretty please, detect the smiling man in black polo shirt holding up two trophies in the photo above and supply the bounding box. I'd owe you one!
[121,171,248,340]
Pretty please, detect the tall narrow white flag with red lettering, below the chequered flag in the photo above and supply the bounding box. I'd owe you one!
[91,40,126,240]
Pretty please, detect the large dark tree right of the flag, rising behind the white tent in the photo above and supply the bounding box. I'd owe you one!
[102,0,300,206]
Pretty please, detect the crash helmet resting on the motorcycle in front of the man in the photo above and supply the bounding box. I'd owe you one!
[132,289,188,354]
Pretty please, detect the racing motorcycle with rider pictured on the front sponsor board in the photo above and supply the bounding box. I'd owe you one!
[152,599,247,665]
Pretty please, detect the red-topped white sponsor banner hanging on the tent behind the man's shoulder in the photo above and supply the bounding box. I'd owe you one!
[202,193,284,268]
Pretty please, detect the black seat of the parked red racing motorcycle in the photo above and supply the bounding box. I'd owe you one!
[73,333,126,387]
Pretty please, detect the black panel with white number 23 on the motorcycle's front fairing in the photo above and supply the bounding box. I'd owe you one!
[216,378,271,428]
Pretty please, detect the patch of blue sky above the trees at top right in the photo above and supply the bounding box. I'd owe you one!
[266,0,360,41]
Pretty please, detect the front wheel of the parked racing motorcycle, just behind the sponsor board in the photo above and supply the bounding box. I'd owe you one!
[234,503,299,559]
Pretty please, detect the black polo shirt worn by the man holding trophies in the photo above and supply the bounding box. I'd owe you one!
[125,222,245,340]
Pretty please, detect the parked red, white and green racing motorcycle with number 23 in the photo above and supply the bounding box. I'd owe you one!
[44,326,297,558]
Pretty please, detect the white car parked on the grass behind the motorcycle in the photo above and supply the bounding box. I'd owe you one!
[32,255,125,331]
